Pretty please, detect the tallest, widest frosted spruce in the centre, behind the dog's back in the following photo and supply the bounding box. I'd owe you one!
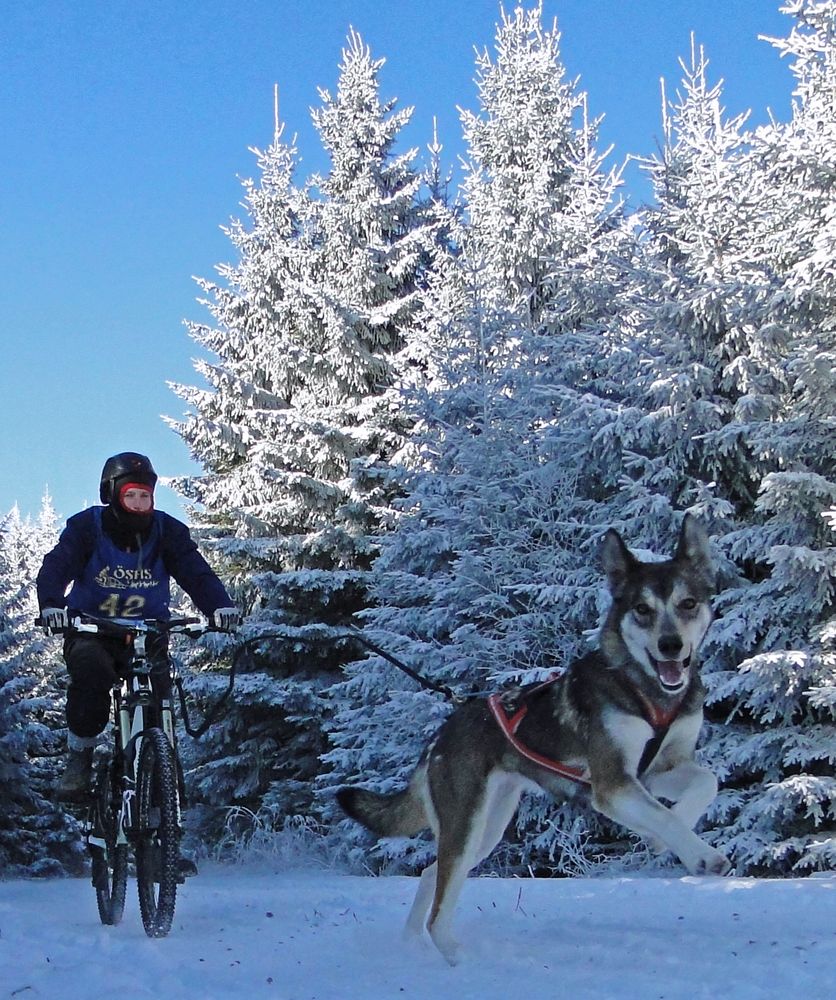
[323,7,648,865]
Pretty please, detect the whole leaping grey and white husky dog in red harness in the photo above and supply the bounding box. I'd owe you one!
[338,516,731,964]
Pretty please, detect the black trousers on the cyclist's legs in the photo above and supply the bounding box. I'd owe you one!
[64,632,171,739]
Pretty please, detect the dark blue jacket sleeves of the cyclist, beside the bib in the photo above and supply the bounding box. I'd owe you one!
[37,507,233,617]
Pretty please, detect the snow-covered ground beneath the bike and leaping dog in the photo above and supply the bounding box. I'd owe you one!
[0,863,836,1000]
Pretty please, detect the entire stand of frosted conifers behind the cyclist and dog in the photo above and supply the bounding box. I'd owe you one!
[0,0,836,876]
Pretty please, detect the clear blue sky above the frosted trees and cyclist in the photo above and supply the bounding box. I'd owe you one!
[0,0,792,517]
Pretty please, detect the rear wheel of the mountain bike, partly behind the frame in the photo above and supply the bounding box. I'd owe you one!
[87,762,128,925]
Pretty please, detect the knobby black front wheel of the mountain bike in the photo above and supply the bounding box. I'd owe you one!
[135,729,180,937]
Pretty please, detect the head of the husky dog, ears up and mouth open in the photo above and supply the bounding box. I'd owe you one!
[602,517,714,694]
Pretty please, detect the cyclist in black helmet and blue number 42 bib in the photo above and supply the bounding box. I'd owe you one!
[37,451,240,801]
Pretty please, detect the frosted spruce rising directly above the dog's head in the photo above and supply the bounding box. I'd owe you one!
[623,33,775,548]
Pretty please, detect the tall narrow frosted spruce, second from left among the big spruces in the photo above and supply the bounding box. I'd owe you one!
[310,25,444,532]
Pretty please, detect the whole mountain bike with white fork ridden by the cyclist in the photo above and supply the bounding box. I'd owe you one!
[48,615,229,938]
